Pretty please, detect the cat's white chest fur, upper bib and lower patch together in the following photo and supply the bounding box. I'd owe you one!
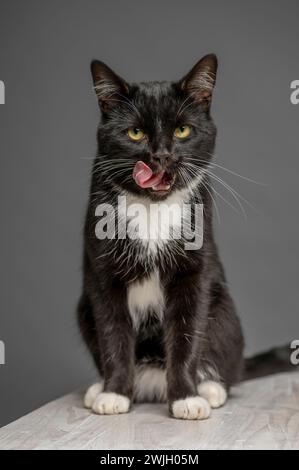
[124,180,199,330]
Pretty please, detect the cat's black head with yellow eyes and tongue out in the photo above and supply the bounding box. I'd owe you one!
[91,54,217,199]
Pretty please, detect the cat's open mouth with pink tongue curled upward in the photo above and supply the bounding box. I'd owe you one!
[133,161,175,192]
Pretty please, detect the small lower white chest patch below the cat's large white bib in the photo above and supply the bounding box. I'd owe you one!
[127,270,164,330]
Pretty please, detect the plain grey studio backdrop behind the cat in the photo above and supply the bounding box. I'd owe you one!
[0,0,299,425]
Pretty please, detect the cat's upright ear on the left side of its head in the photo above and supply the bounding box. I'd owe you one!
[90,60,129,112]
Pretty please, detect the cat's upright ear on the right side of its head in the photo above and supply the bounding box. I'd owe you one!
[180,54,218,110]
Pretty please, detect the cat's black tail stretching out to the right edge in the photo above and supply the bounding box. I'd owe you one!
[242,345,299,380]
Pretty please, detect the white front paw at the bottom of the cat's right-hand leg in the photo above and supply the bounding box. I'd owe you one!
[172,397,211,419]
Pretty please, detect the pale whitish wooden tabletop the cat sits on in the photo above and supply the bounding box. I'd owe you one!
[0,373,299,450]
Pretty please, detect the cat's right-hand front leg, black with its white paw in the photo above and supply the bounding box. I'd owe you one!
[165,275,211,419]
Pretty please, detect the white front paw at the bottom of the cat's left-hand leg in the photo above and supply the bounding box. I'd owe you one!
[92,392,130,415]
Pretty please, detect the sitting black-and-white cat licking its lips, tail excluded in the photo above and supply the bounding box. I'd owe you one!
[78,55,294,419]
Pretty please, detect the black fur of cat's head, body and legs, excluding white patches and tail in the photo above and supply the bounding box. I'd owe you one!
[78,55,243,414]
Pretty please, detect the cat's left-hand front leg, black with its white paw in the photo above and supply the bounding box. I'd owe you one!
[90,289,135,414]
